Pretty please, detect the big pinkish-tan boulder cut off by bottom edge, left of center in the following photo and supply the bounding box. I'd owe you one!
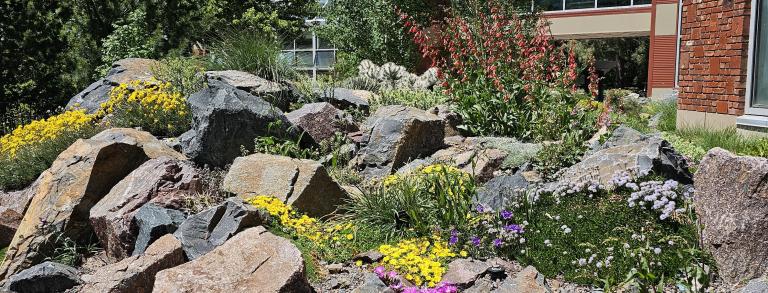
[153,226,311,293]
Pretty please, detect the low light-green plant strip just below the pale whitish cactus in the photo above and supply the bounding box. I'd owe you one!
[368,89,448,112]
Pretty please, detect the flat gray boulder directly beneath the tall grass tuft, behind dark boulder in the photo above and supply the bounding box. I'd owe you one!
[205,70,295,111]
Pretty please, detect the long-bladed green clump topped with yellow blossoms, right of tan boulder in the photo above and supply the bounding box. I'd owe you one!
[345,165,475,235]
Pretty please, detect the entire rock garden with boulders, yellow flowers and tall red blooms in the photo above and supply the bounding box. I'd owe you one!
[0,2,768,293]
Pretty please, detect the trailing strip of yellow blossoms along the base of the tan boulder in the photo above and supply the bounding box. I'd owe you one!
[246,195,355,245]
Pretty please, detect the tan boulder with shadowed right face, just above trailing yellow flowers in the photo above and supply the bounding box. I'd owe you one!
[221,154,347,217]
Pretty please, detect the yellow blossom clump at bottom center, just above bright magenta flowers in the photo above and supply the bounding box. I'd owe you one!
[379,236,456,287]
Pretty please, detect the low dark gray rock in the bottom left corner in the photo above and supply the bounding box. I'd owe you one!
[5,261,82,293]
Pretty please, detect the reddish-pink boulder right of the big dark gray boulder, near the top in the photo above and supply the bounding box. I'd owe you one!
[285,103,359,142]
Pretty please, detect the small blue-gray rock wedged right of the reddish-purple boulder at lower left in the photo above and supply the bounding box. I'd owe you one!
[131,203,186,255]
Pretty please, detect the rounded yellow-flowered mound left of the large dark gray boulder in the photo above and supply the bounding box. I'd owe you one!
[99,80,191,135]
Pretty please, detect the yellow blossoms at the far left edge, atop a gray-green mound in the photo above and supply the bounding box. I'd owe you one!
[0,110,95,158]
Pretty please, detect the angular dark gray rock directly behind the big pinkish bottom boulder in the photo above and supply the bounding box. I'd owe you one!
[174,198,268,260]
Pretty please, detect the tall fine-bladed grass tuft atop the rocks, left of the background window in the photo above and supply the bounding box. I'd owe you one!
[208,30,296,81]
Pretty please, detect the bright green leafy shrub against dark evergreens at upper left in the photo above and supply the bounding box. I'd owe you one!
[97,9,162,76]
